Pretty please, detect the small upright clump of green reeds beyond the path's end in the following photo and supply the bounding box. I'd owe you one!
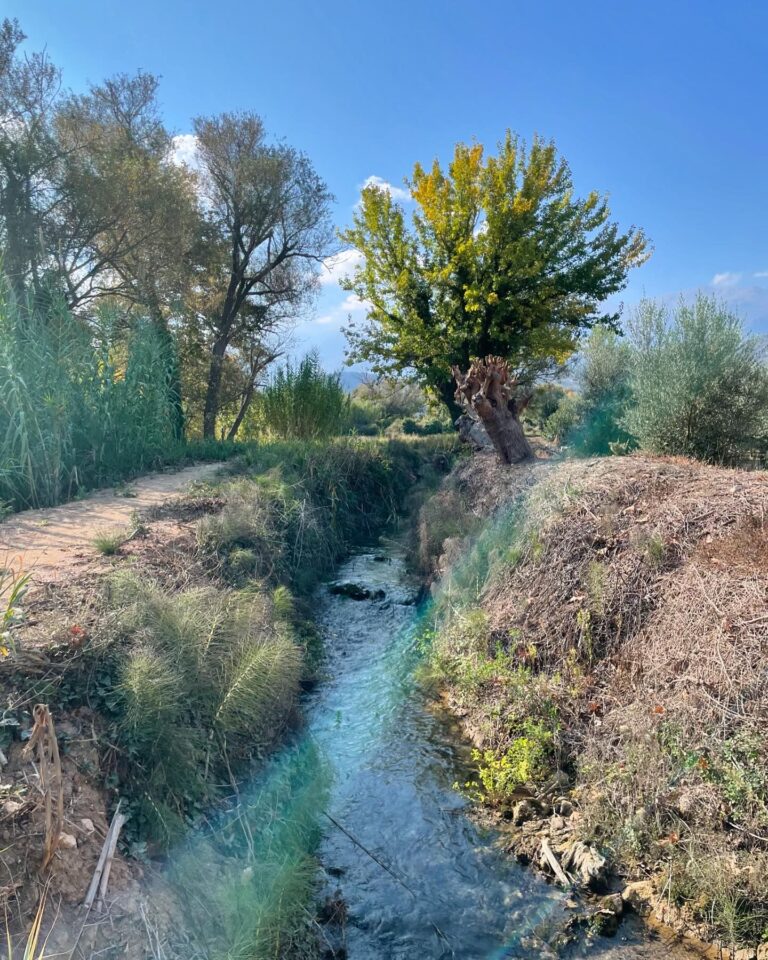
[250,352,350,440]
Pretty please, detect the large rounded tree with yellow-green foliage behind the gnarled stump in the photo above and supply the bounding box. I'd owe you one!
[342,133,648,413]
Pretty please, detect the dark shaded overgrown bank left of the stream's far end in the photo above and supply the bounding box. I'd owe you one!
[198,436,455,592]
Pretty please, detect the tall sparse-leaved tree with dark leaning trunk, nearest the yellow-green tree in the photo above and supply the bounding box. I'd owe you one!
[190,113,333,437]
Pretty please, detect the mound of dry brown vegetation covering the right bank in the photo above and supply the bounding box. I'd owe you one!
[424,456,768,943]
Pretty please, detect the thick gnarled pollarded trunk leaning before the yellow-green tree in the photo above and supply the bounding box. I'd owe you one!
[453,357,533,463]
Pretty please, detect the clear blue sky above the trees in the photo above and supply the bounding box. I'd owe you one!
[10,0,768,365]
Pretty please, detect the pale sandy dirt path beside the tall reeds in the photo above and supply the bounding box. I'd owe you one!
[0,463,221,584]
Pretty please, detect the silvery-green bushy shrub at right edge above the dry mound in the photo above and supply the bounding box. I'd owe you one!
[624,295,768,463]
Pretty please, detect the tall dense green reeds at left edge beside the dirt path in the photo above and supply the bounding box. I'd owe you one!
[0,289,180,509]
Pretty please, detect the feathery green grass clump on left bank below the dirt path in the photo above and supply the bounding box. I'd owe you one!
[96,573,302,846]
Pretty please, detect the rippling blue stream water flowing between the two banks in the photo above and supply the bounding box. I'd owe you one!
[307,553,708,960]
